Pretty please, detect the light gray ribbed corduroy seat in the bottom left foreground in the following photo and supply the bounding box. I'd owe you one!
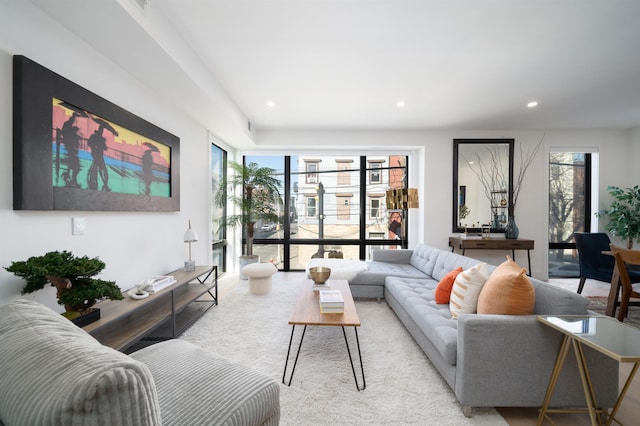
[0,300,280,426]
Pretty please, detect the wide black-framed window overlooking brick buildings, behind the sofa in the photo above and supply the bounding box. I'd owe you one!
[244,155,407,270]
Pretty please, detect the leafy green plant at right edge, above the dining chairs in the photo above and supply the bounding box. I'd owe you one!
[596,185,640,249]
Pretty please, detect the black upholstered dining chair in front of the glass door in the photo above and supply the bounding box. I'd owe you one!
[573,232,640,296]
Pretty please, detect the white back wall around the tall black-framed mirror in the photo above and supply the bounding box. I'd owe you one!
[256,131,640,279]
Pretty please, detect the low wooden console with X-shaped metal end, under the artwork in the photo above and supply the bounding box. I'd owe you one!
[82,266,218,353]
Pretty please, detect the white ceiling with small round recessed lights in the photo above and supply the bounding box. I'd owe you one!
[27,0,640,136]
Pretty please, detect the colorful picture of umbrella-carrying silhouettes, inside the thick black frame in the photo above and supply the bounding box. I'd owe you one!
[52,98,171,197]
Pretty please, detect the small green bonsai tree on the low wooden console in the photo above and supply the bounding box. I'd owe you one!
[5,251,123,319]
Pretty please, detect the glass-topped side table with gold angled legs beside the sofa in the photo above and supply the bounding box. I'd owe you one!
[537,315,640,425]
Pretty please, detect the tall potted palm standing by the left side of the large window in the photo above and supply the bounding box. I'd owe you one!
[214,161,281,278]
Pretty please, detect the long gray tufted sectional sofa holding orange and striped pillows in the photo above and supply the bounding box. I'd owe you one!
[349,245,618,416]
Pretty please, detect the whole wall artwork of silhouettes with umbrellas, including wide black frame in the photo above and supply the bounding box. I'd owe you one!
[13,56,180,211]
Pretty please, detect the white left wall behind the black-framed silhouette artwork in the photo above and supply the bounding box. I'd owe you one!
[0,2,211,311]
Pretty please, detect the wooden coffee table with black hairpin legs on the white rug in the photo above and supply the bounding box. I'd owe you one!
[282,280,366,390]
